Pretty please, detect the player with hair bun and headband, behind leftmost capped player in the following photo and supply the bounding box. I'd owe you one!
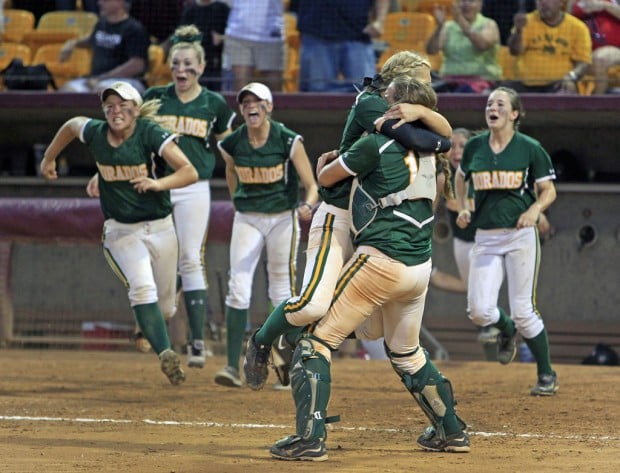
[144,25,235,368]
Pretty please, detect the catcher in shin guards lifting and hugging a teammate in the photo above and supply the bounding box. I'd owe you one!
[270,81,470,461]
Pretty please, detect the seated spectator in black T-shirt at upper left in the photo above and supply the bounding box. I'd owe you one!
[60,0,150,93]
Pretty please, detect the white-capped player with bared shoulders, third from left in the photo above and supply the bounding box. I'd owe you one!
[215,82,318,387]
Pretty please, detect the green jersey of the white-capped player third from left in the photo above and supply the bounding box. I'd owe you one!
[220,120,302,213]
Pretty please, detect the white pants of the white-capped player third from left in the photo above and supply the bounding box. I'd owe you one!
[226,210,300,309]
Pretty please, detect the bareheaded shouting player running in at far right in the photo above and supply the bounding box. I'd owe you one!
[455,87,559,396]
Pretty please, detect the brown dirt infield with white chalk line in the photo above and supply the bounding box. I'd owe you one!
[0,349,620,473]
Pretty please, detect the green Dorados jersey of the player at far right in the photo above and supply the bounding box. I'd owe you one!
[460,132,555,230]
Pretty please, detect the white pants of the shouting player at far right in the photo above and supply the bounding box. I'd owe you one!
[467,227,544,338]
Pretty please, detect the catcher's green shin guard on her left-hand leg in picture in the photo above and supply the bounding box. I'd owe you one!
[290,335,338,440]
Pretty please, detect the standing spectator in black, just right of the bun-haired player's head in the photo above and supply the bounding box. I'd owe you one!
[162,0,230,90]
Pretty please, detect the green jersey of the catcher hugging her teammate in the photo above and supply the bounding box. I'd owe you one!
[342,133,435,266]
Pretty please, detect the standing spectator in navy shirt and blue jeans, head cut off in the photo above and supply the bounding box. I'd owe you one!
[297,0,390,92]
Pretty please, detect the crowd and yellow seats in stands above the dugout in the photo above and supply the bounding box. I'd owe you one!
[0,0,620,95]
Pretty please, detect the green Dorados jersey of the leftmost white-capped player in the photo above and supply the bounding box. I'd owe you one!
[80,118,176,223]
